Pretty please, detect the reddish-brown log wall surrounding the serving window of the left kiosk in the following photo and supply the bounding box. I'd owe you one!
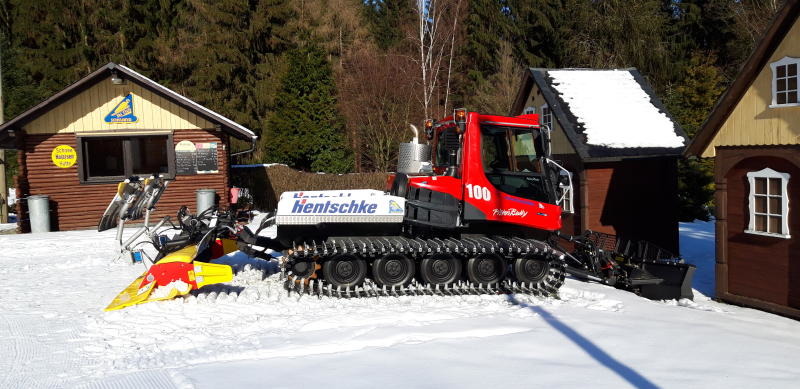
[17,130,229,231]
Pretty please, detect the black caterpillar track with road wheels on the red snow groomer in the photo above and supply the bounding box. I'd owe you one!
[286,236,566,297]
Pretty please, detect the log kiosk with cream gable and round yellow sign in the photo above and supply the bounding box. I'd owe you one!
[0,63,256,231]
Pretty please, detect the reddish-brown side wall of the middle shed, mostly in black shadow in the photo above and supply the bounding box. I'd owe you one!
[583,158,679,253]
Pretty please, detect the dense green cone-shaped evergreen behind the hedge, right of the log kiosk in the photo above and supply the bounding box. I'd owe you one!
[263,44,353,173]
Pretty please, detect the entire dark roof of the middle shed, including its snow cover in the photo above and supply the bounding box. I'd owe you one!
[513,68,687,161]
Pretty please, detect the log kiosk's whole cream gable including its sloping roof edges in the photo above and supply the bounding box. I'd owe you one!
[0,62,258,143]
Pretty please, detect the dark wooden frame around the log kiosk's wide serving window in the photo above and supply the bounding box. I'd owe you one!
[76,131,175,184]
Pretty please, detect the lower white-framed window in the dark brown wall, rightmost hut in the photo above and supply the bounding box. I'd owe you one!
[745,168,791,238]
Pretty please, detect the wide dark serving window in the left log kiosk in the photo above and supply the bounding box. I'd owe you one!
[78,134,175,183]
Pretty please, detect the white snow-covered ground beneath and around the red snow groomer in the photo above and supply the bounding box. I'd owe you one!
[0,223,800,388]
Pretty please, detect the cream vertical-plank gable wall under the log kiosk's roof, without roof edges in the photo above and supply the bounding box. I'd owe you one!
[24,79,214,135]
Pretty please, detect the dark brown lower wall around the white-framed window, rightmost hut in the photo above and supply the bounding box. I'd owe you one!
[717,148,800,313]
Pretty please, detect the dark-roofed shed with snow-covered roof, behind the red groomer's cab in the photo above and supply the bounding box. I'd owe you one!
[511,68,686,253]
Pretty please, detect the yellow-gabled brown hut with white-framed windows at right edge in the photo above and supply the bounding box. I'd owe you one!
[686,0,800,319]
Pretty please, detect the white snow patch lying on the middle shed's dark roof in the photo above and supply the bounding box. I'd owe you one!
[548,70,684,148]
